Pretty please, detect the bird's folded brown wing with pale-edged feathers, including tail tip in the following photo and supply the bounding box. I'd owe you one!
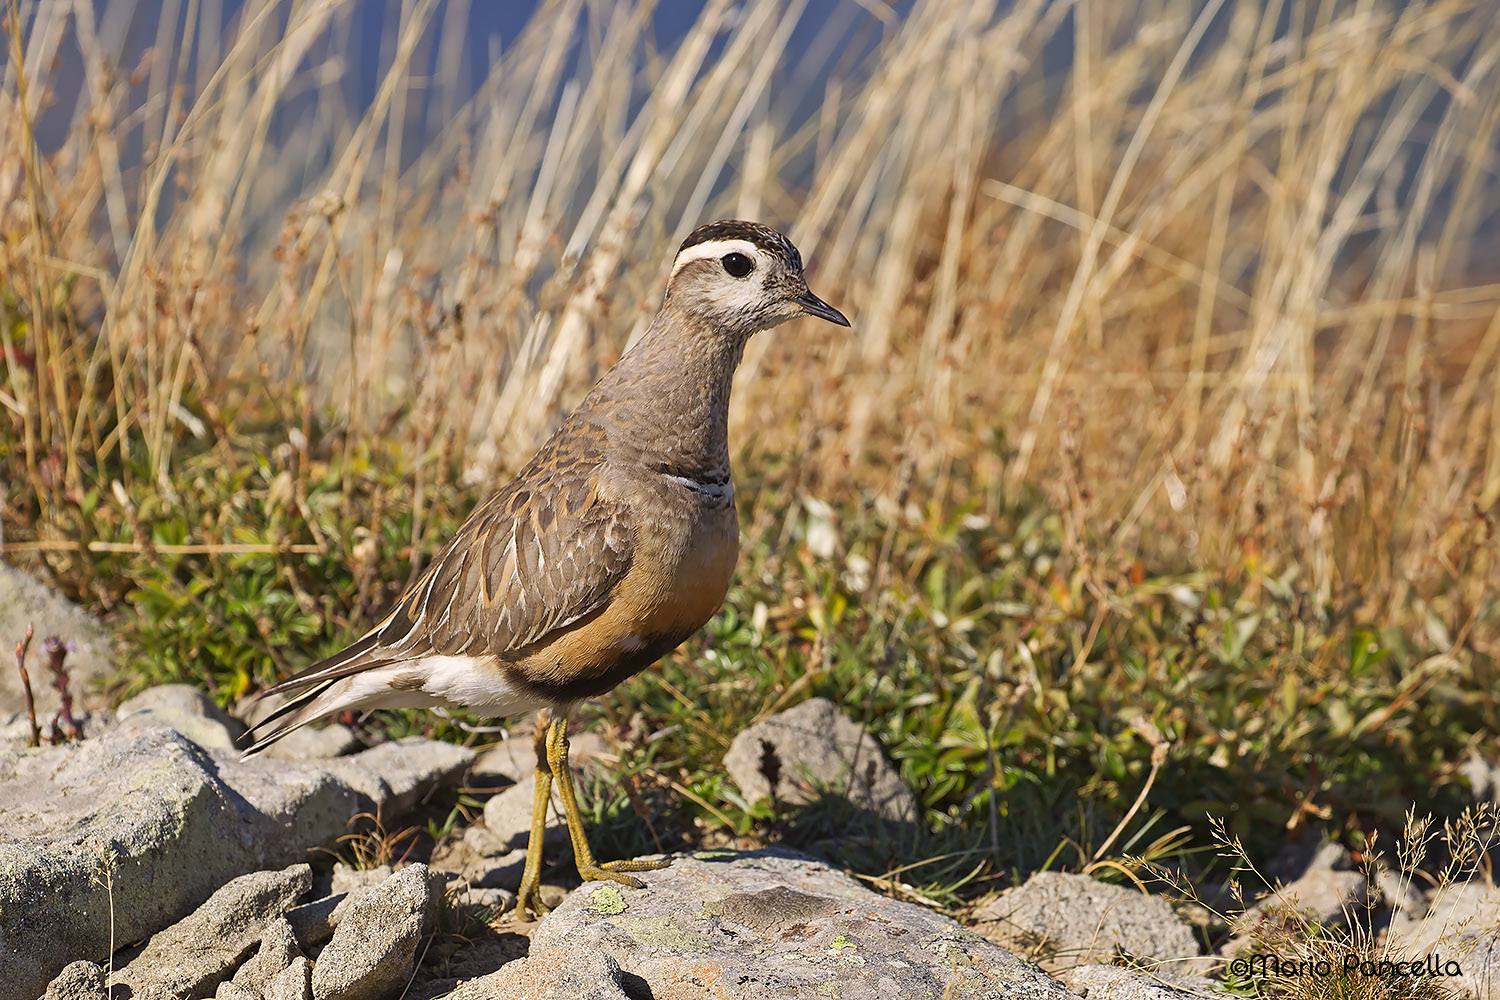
[251,425,636,753]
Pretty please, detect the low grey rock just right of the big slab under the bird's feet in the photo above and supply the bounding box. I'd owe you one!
[974,871,1200,967]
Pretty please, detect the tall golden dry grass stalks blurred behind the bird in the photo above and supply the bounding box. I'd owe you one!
[0,0,1500,644]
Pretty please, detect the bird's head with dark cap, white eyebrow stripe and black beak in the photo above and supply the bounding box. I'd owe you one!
[666,219,849,337]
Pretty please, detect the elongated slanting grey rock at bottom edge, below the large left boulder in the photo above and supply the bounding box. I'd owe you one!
[116,864,312,1000]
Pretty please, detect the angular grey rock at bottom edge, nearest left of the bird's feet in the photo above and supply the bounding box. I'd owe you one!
[312,864,441,1000]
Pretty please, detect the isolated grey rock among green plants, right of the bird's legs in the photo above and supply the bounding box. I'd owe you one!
[725,699,917,822]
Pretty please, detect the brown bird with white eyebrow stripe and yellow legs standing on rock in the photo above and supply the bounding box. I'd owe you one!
[245,219,849,919]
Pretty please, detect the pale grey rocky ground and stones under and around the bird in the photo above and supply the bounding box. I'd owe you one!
[0,569,1500,1000]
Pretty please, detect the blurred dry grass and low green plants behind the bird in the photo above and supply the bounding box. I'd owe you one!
[0,0,1500,906]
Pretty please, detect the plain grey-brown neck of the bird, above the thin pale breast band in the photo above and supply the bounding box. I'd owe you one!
[579,300,747,483]
